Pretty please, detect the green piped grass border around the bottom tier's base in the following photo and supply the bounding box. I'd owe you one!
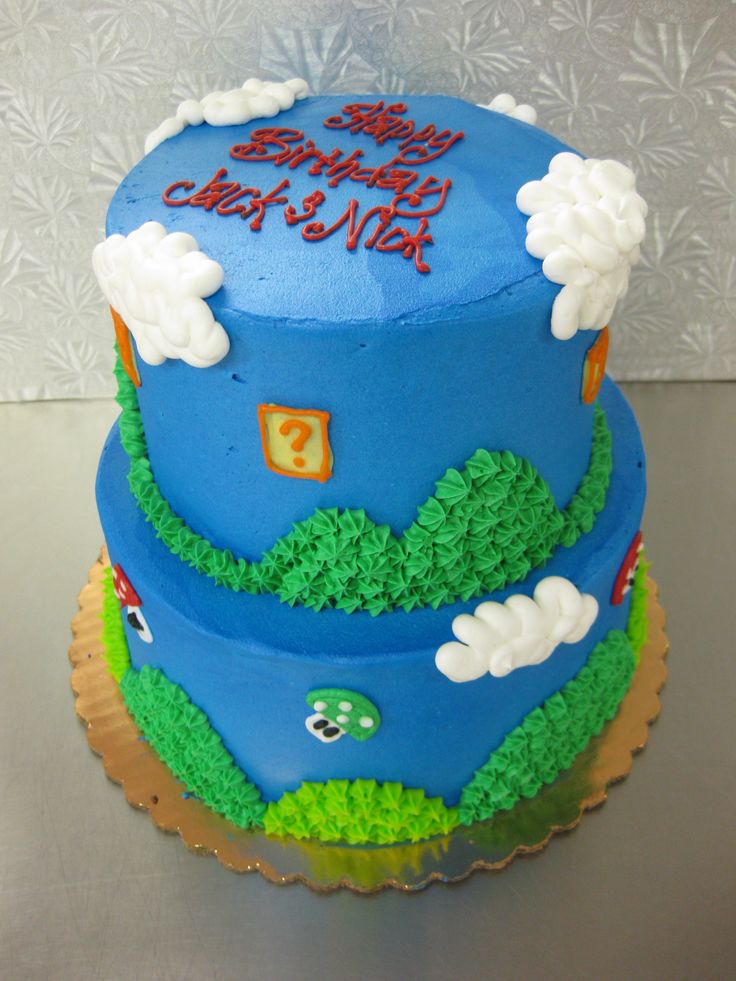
[103,563,647,844]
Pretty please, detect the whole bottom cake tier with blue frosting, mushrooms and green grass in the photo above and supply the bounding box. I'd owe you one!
[98,381,645,841]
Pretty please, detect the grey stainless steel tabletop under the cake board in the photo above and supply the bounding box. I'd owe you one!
[0,383,736,981]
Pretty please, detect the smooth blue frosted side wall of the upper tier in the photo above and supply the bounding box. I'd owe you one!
[138,284,593,560]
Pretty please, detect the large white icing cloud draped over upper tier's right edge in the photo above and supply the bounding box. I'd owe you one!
[516,153,647,340]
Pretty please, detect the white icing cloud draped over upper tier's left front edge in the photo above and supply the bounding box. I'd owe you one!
[92,221,230,368]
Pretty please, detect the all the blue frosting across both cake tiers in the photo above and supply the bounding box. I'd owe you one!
[98,95,645,804]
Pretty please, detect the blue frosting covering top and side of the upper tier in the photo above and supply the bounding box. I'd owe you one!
[107,95,595,559]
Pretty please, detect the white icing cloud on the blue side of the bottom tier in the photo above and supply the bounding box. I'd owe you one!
[435,576,598,682]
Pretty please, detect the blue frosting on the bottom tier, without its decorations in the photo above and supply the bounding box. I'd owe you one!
[98,376,644,804]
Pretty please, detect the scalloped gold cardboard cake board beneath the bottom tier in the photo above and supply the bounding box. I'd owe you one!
[69,549,668,893]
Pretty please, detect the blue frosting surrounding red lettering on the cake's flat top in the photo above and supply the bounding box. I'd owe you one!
[107,95,568,320]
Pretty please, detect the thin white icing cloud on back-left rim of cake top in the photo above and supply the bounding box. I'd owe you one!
[145,78,309,153]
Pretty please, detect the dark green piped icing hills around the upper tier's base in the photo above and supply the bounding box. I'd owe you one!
[115,356,612,615]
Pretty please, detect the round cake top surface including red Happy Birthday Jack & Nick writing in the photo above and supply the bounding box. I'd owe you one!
[107,95,567,325]
